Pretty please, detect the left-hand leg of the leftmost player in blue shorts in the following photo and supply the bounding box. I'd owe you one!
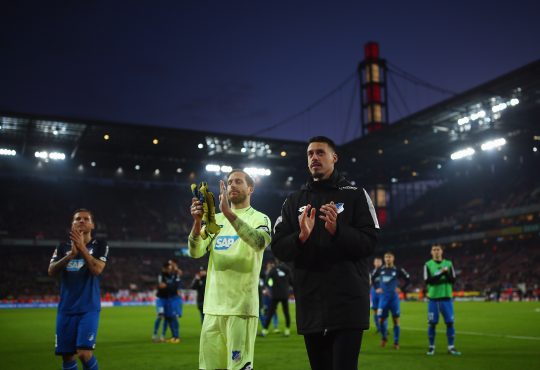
[54,312,79,370]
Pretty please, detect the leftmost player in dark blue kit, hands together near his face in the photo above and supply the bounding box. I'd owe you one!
[49,209,109,370]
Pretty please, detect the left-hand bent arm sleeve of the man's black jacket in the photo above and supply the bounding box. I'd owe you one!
[270,198,309,262]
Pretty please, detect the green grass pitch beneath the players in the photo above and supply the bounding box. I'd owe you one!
[0,302,540,370]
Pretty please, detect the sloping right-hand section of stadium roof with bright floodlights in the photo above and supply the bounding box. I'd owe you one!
[341,61,540,183]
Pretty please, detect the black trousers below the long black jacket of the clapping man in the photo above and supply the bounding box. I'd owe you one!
[304,329,364,370]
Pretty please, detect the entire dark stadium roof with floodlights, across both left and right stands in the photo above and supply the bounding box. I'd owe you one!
[0,61,540,186]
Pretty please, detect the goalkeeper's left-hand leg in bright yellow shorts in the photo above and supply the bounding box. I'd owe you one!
[199,314,228,369]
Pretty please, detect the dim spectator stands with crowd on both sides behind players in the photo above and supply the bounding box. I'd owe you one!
[0,168,540,302]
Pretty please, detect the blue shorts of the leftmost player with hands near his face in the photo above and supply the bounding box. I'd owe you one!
[54,311,99,355]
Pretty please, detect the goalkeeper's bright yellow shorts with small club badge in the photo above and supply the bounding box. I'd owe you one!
[199,314,258,370]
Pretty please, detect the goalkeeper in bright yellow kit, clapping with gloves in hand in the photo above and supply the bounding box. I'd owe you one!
[188,170,271,370]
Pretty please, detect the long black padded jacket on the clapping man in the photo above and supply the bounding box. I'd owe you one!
[272,170,379,334]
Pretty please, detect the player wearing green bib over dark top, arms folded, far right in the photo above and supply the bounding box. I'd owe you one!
[424,244,461,356]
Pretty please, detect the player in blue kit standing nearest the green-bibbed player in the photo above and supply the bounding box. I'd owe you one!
[374,252,410,349]
